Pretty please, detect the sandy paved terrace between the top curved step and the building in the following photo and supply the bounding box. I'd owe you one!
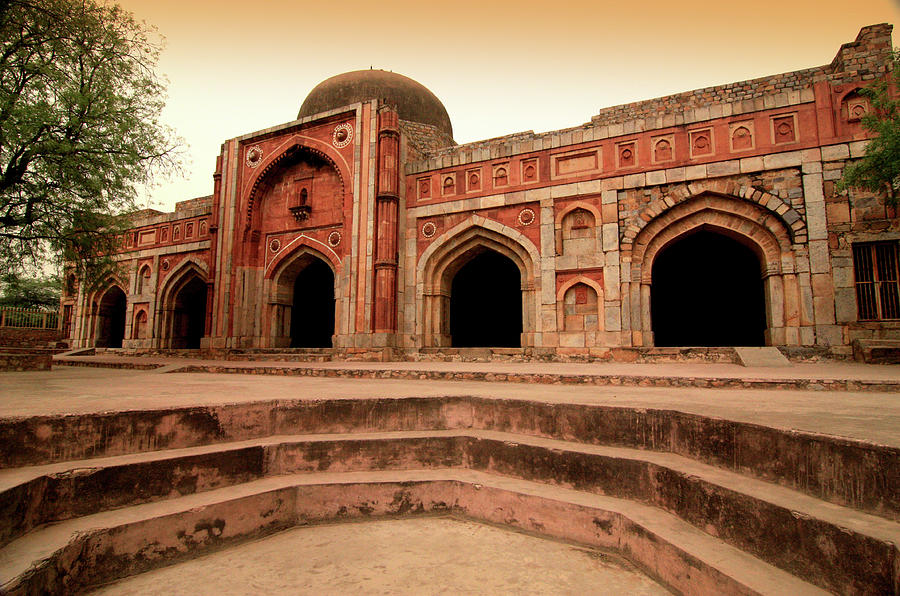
[0,359,900,447]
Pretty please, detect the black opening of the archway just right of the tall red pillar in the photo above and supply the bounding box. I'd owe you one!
[450,250,522,348]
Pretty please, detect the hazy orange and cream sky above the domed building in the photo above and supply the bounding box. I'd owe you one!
[119,0,900,210]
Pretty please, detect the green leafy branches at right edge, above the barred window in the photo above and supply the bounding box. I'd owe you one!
[837,50,900,205]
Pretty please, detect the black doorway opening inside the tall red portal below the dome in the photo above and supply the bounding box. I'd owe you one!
[291,259,334,348]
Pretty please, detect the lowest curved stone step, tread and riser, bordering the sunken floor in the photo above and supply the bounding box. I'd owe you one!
[0,470,824,595]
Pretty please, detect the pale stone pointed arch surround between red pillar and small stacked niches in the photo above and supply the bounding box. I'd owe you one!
[416,215,541,347]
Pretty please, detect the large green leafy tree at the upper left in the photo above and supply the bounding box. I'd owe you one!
[0,0,179,279]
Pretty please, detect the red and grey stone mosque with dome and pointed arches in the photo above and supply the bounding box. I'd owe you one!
[63,24,900,356]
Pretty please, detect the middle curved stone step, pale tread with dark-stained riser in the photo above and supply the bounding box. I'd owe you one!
[0,430,900,593]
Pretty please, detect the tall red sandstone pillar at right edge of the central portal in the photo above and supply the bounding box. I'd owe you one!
[373,108,400,333]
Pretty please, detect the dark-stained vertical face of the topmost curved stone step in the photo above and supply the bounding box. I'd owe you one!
[0,397,900,520]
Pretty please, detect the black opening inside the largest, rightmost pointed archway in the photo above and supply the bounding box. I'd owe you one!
[650,230,766,347]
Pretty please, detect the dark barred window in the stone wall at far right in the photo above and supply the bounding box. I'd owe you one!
[853,242,900,321]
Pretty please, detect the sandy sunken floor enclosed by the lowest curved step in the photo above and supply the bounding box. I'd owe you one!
[94,518,669,596]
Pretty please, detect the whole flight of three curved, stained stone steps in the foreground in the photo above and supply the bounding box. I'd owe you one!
[0,397,900,594]
